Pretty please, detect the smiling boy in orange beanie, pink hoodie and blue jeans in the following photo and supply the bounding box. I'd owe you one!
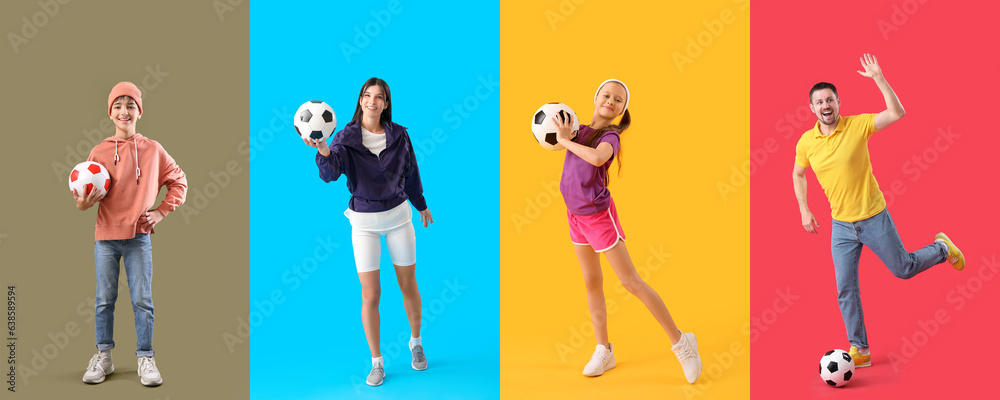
[73,82,187,386]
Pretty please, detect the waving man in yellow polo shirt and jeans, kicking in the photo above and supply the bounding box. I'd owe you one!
[792,54,965,367]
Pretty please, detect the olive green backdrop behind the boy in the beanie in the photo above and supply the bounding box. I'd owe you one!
[0,0,250,400]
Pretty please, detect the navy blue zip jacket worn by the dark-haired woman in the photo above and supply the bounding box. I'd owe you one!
[316,121,427,212]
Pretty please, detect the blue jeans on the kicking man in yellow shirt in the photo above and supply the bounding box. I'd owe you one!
[830,209,948,347]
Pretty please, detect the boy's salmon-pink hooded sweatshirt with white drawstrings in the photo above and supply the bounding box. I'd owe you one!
[87,133,187,240]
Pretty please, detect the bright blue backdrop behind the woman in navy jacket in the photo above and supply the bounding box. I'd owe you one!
[250,0,500,399]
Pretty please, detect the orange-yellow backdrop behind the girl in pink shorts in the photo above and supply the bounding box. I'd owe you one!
[500,0,750,399]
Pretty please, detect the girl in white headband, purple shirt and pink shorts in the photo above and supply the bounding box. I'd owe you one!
[553,79,701,383]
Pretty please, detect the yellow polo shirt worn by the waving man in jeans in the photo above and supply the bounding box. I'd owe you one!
[795,114,885,222]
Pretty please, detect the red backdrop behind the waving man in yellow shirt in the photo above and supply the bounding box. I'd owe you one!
[750,0,1000,399]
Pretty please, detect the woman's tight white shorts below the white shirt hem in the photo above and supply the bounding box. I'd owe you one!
[351,221,417,273]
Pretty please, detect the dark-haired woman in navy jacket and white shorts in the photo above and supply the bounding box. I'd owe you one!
[303,78,434,386]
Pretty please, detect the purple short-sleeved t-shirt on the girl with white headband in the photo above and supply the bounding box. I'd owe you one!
[559,125,620,215]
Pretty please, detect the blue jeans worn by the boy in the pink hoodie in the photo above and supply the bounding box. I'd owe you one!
[94,233,153,357]
